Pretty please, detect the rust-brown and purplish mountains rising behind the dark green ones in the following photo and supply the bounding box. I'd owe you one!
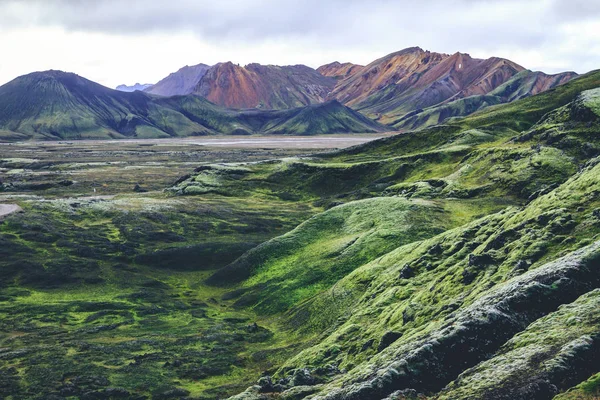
[138,47,577,129]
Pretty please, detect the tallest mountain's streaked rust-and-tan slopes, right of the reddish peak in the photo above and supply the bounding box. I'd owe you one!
[332,47,524,122]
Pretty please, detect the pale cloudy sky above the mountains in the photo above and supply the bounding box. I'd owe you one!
[0,0,600,87]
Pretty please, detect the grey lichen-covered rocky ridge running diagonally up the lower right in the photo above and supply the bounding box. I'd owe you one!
[314,242,600,400]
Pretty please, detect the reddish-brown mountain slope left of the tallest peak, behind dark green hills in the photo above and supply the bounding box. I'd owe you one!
[194,62,337,109]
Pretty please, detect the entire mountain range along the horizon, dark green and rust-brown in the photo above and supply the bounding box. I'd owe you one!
[0,47,577,139]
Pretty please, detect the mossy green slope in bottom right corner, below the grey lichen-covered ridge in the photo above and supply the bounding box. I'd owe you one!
[439,289,600,400]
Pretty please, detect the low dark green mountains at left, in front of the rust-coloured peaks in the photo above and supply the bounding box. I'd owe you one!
[0,71,385,139]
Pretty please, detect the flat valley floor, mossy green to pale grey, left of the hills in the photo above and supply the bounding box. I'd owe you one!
[0,135,390,399]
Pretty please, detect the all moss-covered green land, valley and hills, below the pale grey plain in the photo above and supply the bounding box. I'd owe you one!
[0,67,600,400]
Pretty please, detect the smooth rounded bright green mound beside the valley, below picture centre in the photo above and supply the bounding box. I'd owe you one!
[207,198,449,318]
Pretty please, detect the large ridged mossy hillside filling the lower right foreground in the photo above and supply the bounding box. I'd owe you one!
[225,141,600,399]
